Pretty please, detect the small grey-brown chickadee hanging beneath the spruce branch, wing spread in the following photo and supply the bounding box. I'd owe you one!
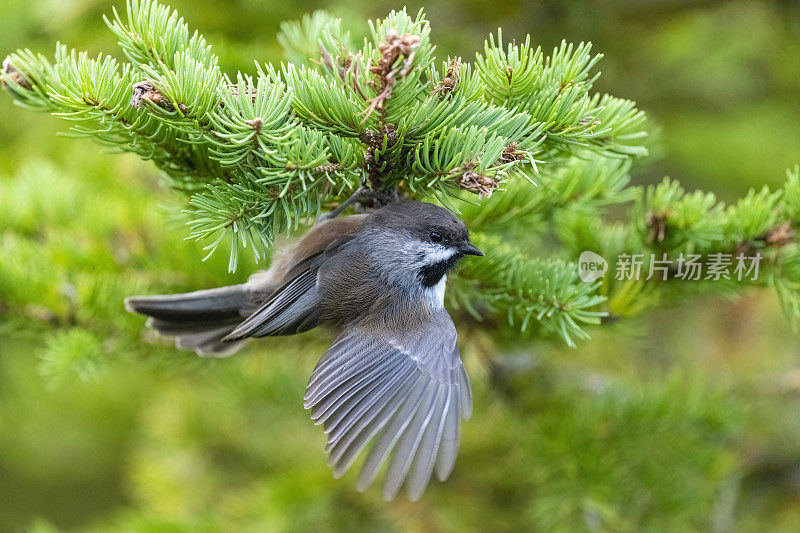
[125,201,483,501]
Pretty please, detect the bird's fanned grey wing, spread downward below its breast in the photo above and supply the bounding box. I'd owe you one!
[305,309,472,500]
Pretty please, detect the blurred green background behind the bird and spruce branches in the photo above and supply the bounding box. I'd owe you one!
[0,0,800,531]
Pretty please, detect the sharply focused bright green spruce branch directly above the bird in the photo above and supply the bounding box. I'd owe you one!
[3,0,643,268]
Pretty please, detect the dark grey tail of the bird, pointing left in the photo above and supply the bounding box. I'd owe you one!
[125,285,252,357]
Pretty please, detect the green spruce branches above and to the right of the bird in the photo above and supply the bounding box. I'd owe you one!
[2,0,800,345]
